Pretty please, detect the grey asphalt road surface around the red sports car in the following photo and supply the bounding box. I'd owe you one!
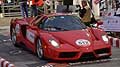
[0,27,120,67]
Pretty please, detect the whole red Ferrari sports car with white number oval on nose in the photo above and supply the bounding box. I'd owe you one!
[10,13,111,60]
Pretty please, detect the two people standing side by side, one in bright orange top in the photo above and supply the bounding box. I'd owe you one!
[19,0,44,18]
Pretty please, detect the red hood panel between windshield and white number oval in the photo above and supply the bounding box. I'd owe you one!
[51,30,92,47]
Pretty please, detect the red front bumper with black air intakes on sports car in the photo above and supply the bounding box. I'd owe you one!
[45,46,111,60]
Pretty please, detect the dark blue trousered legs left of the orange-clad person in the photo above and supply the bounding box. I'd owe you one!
[19,0,28,18]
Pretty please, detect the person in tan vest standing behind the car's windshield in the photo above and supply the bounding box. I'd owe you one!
[79,0,91,27]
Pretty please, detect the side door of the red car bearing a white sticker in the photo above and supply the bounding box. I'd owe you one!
[26,17,44,50]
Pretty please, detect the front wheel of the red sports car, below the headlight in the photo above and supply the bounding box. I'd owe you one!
[36,39,44,59]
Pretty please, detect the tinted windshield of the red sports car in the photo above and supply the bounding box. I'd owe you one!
[43,15,86,31]
